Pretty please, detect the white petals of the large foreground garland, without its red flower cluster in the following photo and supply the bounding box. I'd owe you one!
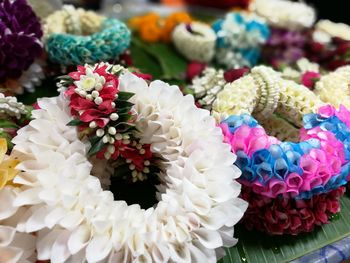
[10,64,247,262]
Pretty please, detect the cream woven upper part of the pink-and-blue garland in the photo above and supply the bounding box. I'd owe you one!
[212,66,323,127]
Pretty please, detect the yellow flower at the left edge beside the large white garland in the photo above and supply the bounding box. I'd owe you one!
[0,138,19,189]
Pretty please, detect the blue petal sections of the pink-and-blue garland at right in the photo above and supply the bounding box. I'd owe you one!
[222,114,350,199]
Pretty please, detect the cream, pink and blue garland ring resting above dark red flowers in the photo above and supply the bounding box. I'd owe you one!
[213,66,350,198]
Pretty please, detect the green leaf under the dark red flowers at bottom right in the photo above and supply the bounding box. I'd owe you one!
[219,195,350,263]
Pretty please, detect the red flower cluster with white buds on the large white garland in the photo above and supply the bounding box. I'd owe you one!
[60,63,153,182]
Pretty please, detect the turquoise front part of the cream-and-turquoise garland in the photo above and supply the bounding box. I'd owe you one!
[45,18,131,66]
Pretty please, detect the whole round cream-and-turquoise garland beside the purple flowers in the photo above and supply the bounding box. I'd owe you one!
[44,6,130,65]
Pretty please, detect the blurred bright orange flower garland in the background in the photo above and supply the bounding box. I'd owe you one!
[129,12,192,43]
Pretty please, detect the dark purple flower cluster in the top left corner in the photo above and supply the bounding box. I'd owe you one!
[0,0,43,82]
